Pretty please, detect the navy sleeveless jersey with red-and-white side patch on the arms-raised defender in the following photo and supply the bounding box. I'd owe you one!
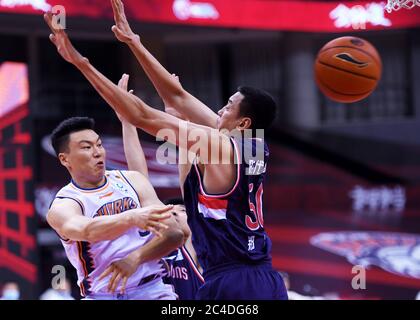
[184,138,271,278]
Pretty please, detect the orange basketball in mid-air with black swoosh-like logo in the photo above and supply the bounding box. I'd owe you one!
[315,37,382,103]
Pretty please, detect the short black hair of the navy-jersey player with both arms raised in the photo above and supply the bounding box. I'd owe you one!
[238,86,277,129]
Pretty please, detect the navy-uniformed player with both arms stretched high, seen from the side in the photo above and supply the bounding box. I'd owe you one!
[45,8,287,300]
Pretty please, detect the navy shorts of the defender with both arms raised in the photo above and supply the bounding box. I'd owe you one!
[196,265,287,300]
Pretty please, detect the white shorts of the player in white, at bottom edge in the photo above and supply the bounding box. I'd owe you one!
[82,278,178,300]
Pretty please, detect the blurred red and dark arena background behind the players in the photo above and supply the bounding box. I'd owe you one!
[0,0,420,299]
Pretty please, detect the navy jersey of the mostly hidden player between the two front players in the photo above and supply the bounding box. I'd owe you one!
[163,246,204,300]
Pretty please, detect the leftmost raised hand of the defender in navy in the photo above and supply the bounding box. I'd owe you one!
[44,12,87,65]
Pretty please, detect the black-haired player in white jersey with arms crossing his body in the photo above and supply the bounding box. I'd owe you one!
[47,118,184,300]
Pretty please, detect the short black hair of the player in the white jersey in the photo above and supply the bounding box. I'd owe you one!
[51,117,95,156]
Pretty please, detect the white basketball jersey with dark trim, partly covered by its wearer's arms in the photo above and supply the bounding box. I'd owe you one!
[54,171,164,296]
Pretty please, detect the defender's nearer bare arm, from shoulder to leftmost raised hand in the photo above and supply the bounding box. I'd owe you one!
[45,13,236,193]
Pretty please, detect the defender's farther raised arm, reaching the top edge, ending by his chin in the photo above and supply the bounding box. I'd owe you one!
[111,0,218,128]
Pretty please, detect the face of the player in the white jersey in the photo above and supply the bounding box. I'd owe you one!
[60,130,106,181]
